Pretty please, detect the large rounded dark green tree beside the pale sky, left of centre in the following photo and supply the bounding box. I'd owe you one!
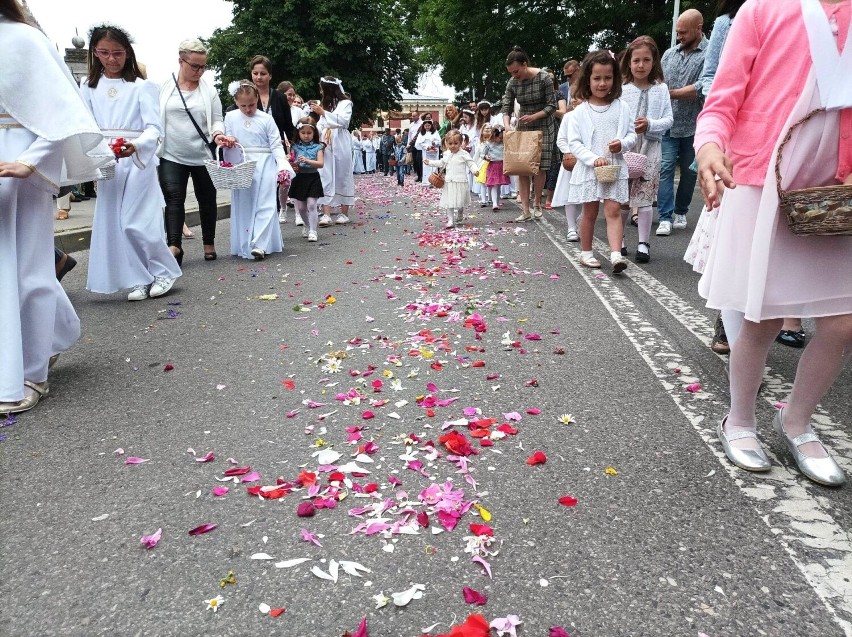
[208,0,423,126]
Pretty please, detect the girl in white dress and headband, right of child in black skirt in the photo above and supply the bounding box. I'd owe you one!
[311,75,355,226]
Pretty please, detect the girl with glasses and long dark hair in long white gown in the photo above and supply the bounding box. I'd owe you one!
[80,25,181,301]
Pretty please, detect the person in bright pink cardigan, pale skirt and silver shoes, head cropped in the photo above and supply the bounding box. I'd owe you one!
[695,0,852,486]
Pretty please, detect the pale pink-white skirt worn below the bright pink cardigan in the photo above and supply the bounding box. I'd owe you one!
[698,72,852,322]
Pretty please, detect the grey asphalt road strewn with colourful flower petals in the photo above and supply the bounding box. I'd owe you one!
[0,176,852,637]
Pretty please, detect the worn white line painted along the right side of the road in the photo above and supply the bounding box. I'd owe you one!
[538,219,852,637]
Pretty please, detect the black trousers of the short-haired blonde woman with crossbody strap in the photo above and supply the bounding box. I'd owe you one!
[157,159,216,247]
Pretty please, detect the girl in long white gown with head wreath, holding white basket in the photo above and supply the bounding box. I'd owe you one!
[216,80,296,261]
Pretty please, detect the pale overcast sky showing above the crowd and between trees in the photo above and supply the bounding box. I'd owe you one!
[27,0,453,98]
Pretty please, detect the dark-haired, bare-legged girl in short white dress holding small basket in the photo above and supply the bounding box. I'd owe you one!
[568,51,636,274]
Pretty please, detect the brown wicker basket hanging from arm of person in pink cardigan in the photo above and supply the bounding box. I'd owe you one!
[775,108,852,235]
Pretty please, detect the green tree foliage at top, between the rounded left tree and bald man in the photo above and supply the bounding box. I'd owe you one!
[414,0,716,101]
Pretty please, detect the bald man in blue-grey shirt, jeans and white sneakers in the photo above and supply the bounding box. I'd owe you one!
[657,9,708,237]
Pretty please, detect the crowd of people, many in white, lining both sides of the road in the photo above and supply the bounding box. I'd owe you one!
[0,0,852,486]
